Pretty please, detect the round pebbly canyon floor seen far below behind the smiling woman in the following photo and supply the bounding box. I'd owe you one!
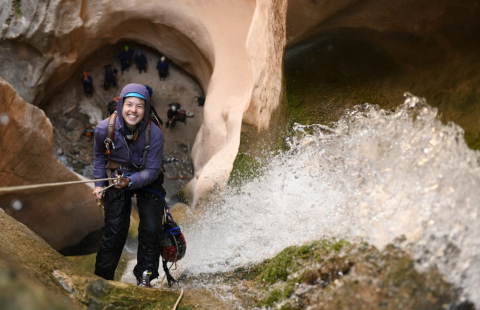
[43,40,204,197]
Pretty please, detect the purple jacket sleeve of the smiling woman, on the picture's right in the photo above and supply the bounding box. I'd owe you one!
[129,124,164,190]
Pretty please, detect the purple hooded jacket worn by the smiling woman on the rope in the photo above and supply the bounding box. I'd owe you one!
[93,84,164,190]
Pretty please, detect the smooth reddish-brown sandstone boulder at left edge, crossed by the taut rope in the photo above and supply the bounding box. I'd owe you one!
[0,78,103,250]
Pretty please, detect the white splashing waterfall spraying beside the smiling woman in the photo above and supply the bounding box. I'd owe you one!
[124,94,480,305]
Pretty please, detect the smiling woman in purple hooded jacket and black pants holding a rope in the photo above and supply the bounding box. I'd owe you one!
[93,84,166,287]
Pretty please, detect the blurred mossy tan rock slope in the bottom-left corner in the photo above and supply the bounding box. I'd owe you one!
[0,209,228,309]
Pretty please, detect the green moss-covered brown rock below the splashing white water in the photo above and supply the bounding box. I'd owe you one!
[225,239,468,310]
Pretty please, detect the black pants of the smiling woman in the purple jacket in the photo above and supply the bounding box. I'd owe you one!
[95,187,165,280]
